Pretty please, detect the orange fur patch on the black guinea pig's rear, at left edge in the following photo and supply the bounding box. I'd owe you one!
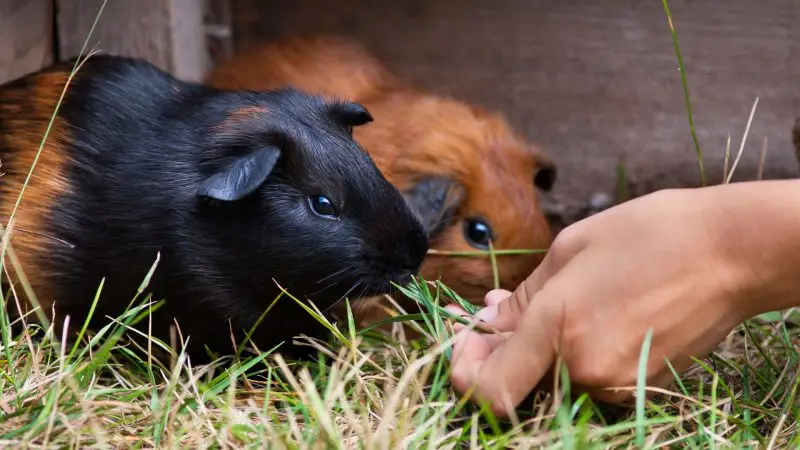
[0,72,70,315]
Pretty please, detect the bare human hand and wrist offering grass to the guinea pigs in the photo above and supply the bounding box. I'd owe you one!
[447,180,800,416]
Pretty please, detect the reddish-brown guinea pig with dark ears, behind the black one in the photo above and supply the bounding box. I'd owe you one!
[207,36,556,316]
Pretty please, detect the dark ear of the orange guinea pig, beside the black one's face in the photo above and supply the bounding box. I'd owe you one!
[403,176,466,238]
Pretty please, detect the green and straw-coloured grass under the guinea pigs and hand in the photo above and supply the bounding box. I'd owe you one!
[0,0,800,449]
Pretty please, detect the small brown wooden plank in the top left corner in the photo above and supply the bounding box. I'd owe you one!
[0,0,53,83]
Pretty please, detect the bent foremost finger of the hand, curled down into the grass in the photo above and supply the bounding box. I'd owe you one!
[451,301,560,416]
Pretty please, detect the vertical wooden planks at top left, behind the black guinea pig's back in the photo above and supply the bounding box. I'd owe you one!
[0,0,230,83]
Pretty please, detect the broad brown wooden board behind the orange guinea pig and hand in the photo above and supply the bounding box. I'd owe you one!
[228,0,800,216]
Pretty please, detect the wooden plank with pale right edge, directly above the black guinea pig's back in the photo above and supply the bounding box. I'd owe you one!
[57,0,209,80]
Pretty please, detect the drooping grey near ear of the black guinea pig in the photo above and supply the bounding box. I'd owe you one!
[197,146,281,202]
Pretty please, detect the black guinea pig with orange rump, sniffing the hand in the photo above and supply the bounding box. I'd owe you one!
[0,56,428,362]
